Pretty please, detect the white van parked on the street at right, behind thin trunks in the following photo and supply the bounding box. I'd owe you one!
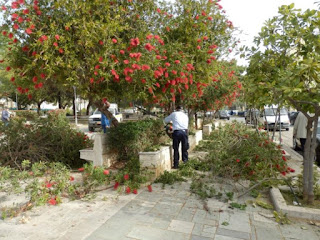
[259,107,290,131]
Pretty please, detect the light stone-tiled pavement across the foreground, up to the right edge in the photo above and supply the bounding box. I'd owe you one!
[85,182,320,240]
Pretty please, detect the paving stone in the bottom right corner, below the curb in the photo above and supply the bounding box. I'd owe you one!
[279,224,319,240]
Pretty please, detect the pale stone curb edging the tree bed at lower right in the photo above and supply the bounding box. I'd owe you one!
[270,187,320,221]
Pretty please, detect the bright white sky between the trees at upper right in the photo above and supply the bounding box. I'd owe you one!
[220,0,320,65]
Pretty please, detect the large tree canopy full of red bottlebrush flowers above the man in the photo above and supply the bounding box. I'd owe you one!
[0,0,239,125]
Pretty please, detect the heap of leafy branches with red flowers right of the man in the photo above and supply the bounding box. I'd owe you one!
[196,122,294,180]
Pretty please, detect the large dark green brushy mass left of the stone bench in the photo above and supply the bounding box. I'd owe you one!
[0,110,92,168]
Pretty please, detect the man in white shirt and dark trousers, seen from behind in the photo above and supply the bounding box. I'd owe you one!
[164,106,189,169]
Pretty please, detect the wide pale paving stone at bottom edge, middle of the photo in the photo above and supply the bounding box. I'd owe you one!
[126,226,190,240]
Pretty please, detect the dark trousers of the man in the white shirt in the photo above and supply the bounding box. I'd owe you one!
[172,130,189,167]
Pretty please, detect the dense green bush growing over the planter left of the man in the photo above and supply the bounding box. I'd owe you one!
[107,120,168,161]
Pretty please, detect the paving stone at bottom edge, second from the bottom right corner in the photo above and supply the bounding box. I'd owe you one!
[253,222,284,240]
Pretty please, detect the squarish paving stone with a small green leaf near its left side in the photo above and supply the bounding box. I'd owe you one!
[219,211,251,233]
